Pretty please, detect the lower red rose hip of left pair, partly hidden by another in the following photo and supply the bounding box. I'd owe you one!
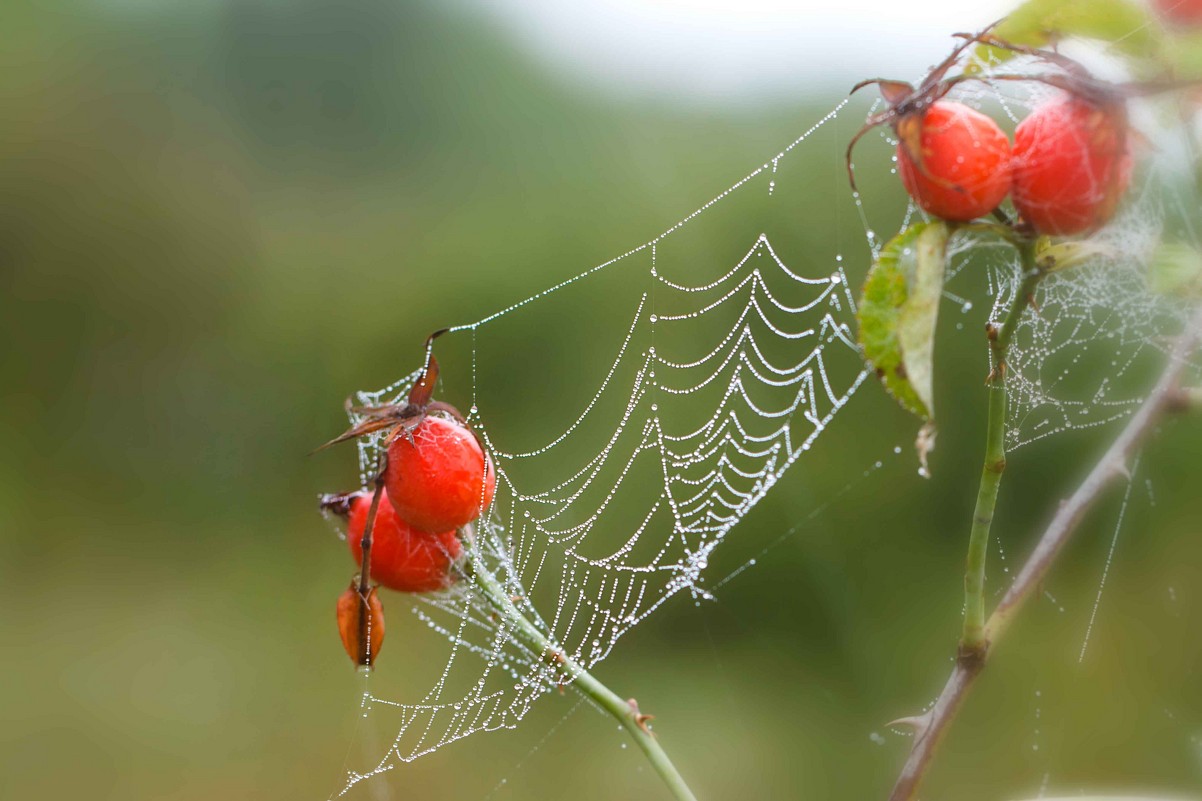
[346,491,463,593]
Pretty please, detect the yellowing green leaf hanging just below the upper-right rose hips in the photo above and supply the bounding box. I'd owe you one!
[858,223,951,420]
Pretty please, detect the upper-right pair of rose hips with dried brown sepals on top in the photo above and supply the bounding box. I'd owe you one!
[849,34,1132,236]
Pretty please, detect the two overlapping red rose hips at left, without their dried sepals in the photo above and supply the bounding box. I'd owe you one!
[345,416,496,593]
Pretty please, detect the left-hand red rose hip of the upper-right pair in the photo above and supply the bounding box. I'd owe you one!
[898,101,1010,223]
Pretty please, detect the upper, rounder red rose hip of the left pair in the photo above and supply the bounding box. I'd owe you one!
[383,417,496,532]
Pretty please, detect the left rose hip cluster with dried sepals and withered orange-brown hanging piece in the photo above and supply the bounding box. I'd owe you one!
[321,332,496,666]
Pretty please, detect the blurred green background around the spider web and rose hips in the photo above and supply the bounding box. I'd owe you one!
[0,0,1202,801]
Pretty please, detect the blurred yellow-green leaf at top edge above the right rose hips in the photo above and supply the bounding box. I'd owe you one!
[970,0,1162,71]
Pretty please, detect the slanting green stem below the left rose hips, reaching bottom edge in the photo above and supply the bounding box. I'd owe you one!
[464,526,696,801]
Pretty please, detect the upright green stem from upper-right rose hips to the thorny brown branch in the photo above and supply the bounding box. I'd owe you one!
[960,243,1043,658]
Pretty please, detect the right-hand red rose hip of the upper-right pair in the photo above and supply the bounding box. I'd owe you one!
[1013,96,1131,236]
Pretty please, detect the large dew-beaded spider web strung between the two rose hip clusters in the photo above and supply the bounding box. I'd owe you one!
[324,105,869,795]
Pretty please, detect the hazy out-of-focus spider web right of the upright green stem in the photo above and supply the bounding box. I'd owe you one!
[953,69,1197,450]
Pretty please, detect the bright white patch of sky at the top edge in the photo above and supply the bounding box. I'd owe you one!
[470,0,1017,101]
